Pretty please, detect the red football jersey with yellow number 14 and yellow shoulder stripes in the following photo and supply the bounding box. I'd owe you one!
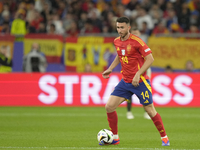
[114,34,152,83]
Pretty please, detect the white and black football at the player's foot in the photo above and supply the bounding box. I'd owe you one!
[97,129,113,145]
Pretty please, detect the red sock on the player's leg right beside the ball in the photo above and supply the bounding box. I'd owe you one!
[107,111,118,134]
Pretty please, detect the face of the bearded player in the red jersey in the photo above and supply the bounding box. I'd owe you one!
[117,22,130,38]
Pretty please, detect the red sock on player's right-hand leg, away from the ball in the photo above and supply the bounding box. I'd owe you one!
[151,113,166,137]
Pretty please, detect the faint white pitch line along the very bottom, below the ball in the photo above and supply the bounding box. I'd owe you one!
[0,146,200,150]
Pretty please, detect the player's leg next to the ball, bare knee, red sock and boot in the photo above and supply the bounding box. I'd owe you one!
[105,95,125,145]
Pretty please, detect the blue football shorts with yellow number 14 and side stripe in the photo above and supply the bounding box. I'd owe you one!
[111,79,153,105]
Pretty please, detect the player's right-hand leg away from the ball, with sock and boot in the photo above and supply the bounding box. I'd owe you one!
[143,103,170,146]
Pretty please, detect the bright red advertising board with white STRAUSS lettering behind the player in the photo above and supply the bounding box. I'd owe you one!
[0,73,200,107]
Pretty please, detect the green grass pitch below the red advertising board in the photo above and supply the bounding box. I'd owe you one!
[0,107,200,150]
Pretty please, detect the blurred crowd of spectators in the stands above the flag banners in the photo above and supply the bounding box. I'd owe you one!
[0,0,200,36]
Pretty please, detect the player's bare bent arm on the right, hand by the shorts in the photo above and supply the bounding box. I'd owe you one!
[132,54,154,86]
